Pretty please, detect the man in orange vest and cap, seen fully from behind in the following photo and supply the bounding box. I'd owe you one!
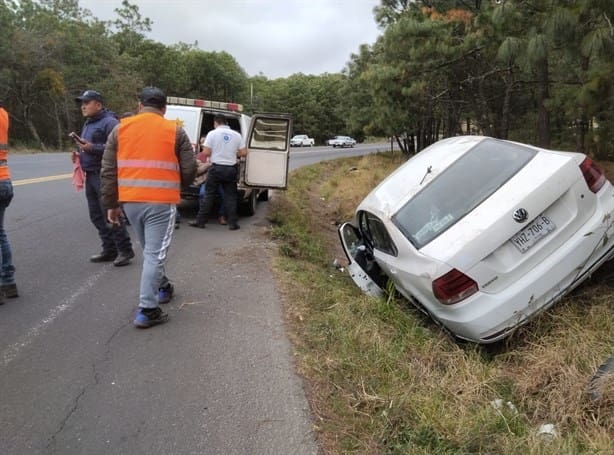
[101,87,196,328]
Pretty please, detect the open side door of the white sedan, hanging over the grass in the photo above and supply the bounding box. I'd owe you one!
[338,223,384,297]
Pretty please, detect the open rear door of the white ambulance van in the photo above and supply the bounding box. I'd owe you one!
[244,114,292,189]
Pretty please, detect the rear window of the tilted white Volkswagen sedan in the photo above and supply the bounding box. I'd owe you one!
[392,139,537,249]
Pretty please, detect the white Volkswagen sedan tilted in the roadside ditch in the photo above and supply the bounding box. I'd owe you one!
[339,136,614,343]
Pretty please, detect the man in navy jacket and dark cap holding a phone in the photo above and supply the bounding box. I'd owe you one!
[70,90,134,267]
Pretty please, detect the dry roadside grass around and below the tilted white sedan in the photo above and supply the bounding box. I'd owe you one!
[270,153,614,455]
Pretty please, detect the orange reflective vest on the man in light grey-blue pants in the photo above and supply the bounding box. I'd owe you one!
[117,112,181,204]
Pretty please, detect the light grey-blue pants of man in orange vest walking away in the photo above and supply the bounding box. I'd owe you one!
[124,202,177,308]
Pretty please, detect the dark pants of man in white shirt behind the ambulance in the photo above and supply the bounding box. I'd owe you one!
[196,164,239,226]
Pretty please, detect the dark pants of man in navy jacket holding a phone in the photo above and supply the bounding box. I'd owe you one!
[85,171,132,252]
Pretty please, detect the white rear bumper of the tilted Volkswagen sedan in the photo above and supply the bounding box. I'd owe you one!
[432,188,614,343]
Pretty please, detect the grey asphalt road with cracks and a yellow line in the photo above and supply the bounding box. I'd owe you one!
[0,144,386,455]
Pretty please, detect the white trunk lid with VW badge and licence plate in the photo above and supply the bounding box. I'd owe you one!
[420,152,596,292]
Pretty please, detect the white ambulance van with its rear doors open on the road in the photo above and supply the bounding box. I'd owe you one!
[165,96,292,215]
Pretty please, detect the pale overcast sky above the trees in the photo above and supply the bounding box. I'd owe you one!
[79,0,380,79]
